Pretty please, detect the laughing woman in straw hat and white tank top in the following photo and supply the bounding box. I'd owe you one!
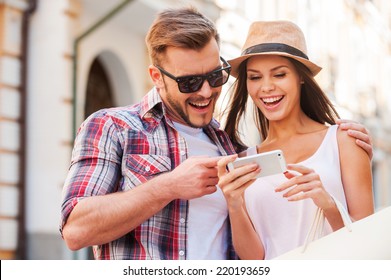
[218,21,374,259]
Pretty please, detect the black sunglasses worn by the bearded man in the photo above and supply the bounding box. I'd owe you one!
[156,57,231,93]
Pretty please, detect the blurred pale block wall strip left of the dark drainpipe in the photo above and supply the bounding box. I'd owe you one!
[0,1,26,259]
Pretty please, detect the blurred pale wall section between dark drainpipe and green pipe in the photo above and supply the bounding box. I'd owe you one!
[26,0,75,259]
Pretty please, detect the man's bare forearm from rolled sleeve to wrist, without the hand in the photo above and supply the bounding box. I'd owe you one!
[62,172,174,250]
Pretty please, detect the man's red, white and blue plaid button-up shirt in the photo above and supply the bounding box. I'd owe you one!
[60,88,236,260]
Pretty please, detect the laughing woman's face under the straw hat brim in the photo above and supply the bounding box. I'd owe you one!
[247,55,301,121]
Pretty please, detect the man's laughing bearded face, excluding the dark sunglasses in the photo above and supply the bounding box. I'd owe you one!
[155,39,222,128]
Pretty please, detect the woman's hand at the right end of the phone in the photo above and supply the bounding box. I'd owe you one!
[275,164,335,210]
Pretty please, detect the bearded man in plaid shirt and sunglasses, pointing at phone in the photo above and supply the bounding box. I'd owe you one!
[60,8,372,260]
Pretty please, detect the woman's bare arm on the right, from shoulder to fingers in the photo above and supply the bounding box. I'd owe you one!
[276,124,373,230]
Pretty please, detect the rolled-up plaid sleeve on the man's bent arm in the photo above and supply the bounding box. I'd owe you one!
[60,111,122,232]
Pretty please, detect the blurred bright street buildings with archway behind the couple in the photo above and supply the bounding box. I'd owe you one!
[0,0,391,259]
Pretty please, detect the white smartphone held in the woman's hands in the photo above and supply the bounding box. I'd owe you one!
[228,150,286,178]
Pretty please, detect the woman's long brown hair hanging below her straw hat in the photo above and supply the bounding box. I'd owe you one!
[224,57,339,151]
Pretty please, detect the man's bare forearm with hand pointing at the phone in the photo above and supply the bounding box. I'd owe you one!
[62,157,219,250]
